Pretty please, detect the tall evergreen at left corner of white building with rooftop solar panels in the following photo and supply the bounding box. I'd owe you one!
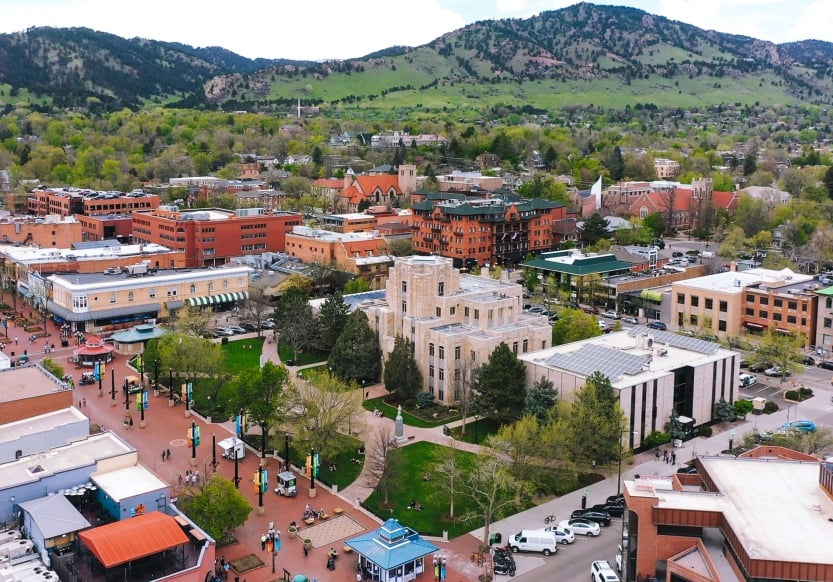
[472,342,526,423]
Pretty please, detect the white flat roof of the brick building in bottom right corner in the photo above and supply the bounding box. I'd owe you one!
[625,456,833,564]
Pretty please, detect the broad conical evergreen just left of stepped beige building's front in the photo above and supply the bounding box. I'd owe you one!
[327,309,382,383]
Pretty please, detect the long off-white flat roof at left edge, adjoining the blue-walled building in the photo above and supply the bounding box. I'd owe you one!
[0,431,136,491]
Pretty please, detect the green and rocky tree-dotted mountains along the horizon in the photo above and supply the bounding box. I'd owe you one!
[0,3,833,110]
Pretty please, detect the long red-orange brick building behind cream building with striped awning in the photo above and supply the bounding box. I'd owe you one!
[133,207,303,267]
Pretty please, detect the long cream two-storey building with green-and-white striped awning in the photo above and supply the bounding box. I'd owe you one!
[44,263,252,333]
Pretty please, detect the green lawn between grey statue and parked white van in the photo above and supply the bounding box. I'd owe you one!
[364,441,498,537]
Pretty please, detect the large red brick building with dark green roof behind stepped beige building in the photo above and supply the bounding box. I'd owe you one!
[411,193,568,267]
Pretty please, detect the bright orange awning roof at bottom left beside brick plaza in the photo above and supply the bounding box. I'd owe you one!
[78,511,188,568]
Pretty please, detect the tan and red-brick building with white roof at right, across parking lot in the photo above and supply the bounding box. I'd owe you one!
[666,268,818,346]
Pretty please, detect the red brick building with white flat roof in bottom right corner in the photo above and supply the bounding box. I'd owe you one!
[622,456,833,582]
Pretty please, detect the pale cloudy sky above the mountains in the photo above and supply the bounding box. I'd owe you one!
[0,0,833,60]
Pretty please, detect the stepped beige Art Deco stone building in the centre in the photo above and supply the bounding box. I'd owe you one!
[358,256,552,405]
